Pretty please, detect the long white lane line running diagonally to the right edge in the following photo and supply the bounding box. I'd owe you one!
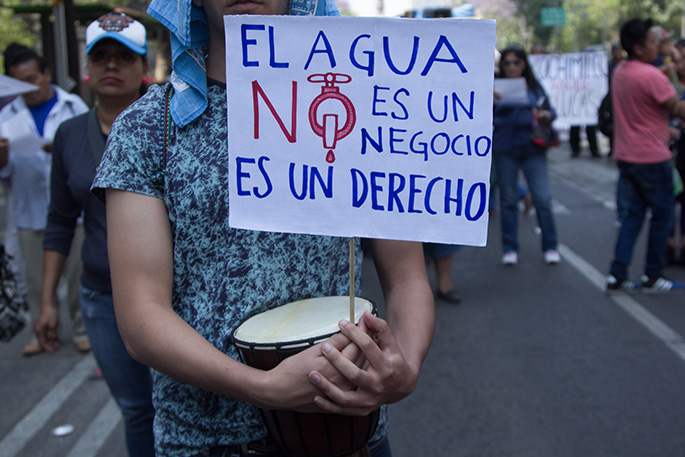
[559,244,685,362]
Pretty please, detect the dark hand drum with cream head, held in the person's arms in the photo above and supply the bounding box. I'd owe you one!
[233,296,379,457]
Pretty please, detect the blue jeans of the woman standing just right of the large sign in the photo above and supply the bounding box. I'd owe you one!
[494,144,557,252]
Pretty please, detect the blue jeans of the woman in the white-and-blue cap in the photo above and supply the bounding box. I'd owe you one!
[81,286,155,457]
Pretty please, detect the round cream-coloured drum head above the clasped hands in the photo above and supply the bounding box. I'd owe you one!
[233,296,373,346]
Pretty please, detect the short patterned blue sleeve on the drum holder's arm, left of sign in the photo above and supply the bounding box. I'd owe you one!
[92,86,165,201]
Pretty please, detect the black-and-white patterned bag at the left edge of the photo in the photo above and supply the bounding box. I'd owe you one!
[0,244,29,342]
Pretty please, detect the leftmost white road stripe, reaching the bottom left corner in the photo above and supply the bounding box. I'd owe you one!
[0,354,96,457]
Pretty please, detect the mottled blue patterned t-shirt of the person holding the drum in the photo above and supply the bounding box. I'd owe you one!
[93,85,385,457]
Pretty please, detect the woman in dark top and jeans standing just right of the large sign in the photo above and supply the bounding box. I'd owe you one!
[492,45,561,266]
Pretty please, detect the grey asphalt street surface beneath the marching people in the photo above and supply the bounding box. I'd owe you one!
[0,137,685,457]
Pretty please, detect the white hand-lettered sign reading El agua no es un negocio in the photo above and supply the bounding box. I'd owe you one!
[224,16,495,246]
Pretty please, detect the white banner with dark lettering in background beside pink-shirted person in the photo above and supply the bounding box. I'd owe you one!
[528,52,609,129]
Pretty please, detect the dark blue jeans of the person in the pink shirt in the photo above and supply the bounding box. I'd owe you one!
[610,160,674,281]
